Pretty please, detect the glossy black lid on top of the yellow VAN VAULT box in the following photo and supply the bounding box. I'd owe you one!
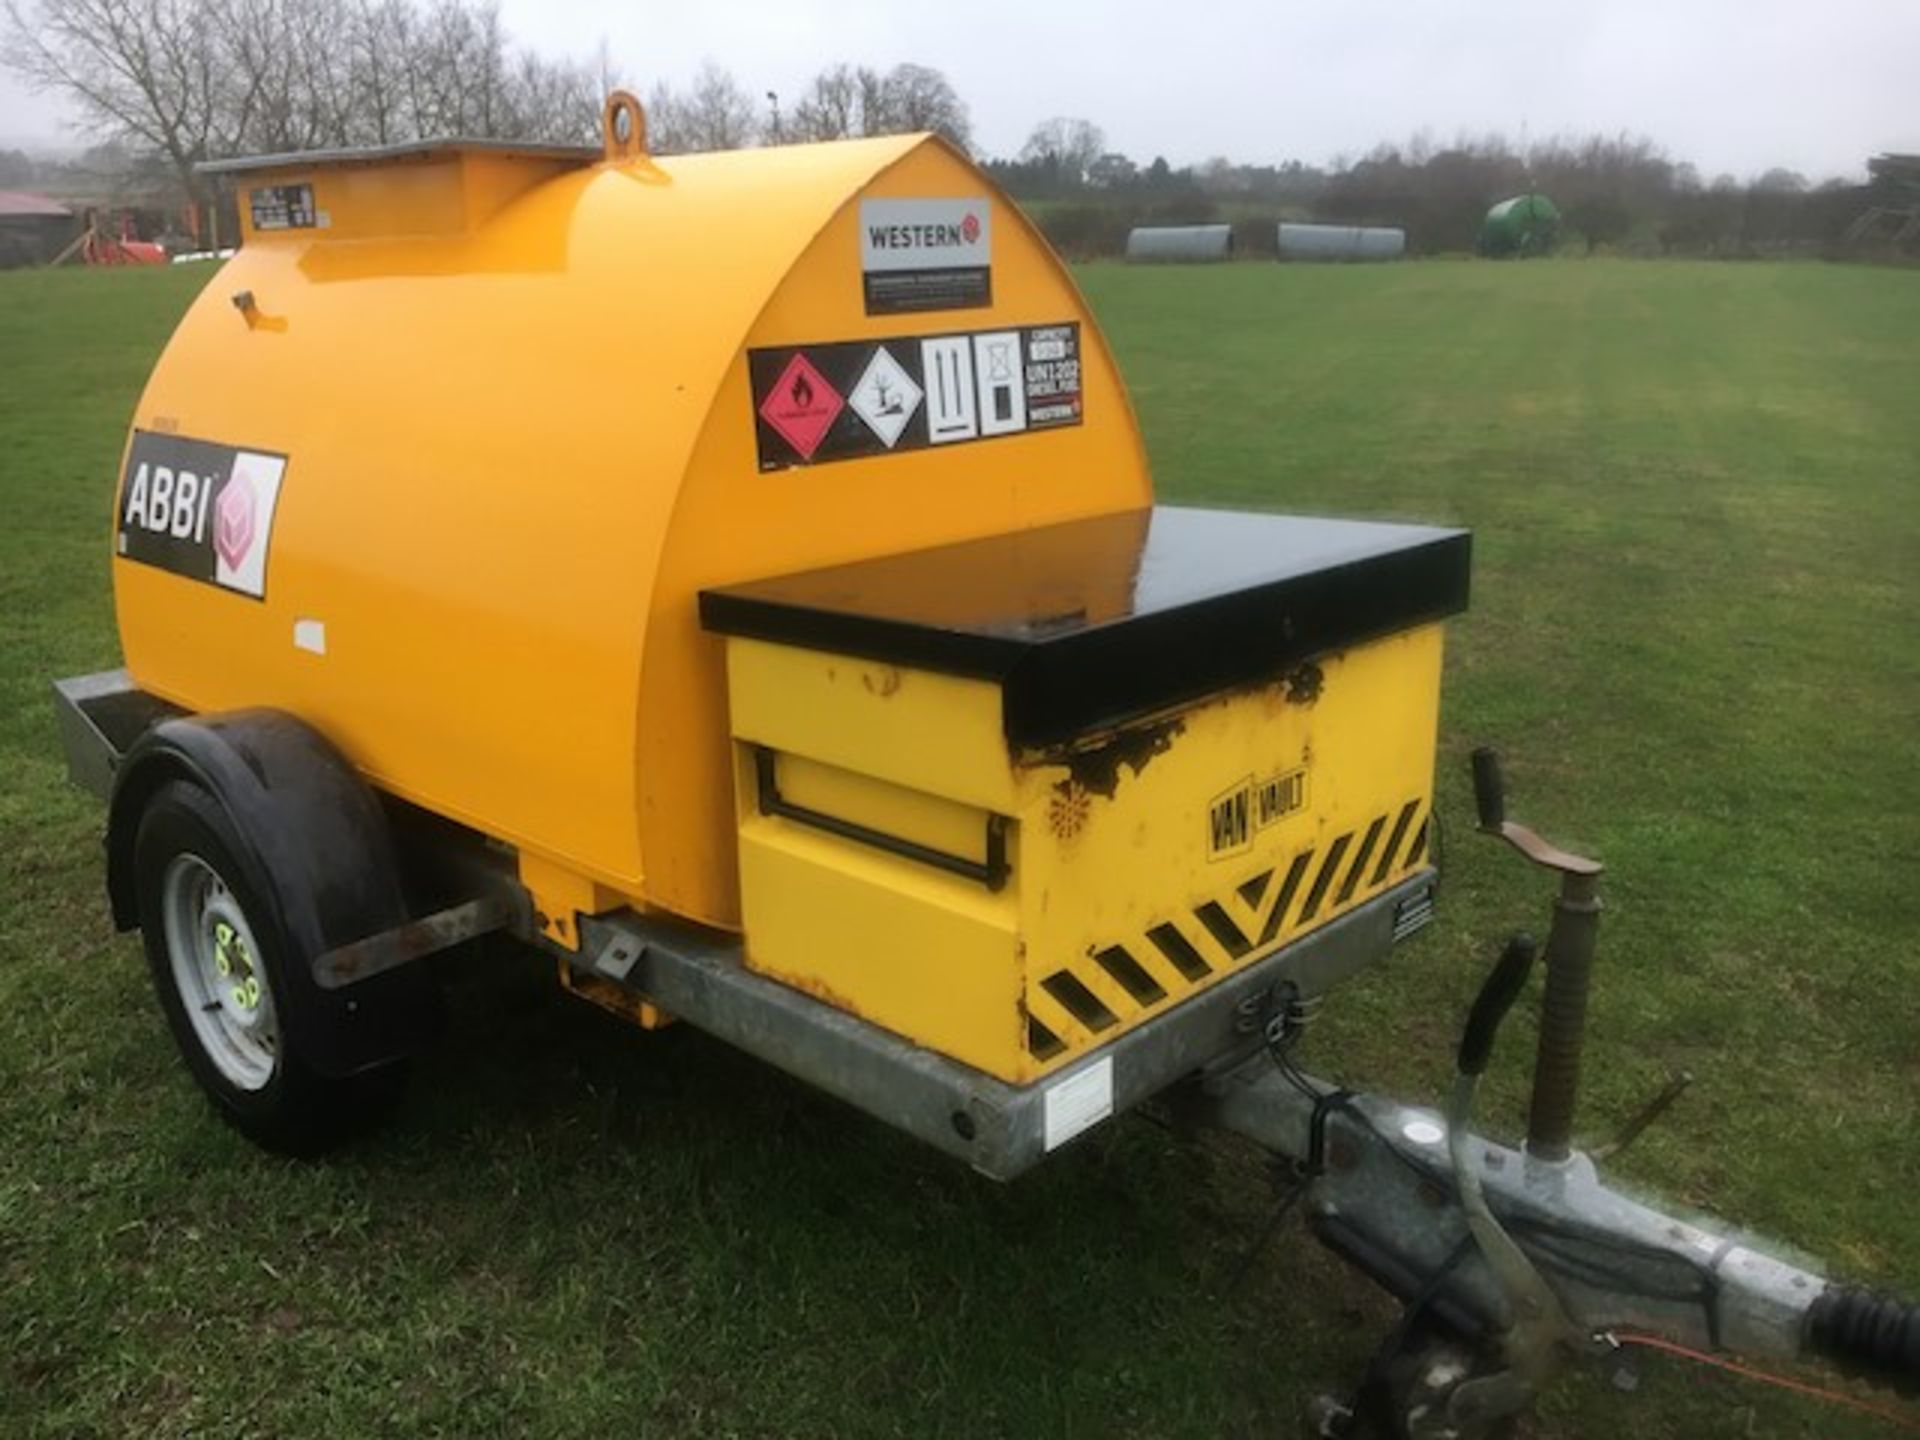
[701,505,1471,745]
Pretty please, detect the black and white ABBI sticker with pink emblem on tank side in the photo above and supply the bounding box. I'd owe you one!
[117,430,286,599]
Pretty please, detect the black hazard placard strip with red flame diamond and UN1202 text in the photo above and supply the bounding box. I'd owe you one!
[747,321,1085,470]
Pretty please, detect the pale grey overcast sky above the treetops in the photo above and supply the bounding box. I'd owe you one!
[0,0,1920,179]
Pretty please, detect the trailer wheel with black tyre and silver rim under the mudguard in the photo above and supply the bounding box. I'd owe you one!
[132,780,401,1154]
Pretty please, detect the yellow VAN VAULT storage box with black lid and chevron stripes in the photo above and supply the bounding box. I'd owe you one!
[703,507,1469,1083]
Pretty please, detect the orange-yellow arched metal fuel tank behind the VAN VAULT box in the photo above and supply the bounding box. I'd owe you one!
[113,107,1150,945]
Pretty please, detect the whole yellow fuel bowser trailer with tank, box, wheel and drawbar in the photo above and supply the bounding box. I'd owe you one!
[58,96,1905,1432]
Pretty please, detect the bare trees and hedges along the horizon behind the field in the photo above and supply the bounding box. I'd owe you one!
[0,0,1881,253]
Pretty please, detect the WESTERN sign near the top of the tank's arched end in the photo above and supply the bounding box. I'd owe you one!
[860,196,993,315]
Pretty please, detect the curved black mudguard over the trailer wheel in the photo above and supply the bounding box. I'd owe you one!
[108,710,440,1077]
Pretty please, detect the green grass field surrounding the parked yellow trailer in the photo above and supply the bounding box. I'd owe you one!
[0,263,1920,1440]
